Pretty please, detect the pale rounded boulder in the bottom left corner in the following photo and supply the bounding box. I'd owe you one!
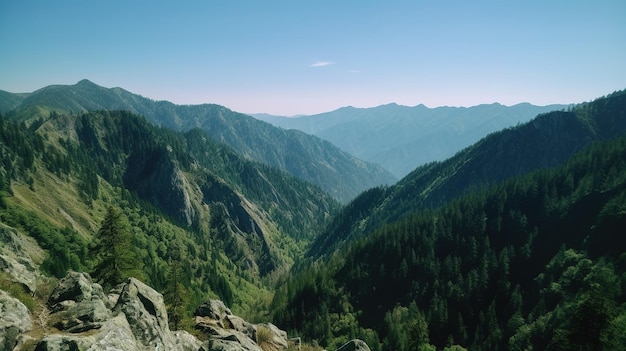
[0,290,32,350]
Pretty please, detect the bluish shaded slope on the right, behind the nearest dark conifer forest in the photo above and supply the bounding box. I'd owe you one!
[310,91,626,257]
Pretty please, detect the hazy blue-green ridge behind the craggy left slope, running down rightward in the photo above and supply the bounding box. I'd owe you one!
[0,80,396,202]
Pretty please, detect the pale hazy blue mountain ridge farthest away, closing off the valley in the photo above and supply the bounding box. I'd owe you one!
[253,103,567,178]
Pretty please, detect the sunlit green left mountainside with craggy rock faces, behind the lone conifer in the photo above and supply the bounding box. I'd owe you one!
[0,111,339,320]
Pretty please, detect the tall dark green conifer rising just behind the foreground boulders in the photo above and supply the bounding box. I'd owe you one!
[93,206,143,287]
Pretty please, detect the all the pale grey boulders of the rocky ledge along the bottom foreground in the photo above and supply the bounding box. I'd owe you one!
[0,272,369,351]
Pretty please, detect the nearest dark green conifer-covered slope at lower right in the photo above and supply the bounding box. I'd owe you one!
[272,133,626,350]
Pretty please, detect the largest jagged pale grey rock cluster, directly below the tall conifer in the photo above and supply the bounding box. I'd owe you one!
[37,272,201,351]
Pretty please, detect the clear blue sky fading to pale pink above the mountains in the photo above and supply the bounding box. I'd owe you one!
[0,0,626,115]
